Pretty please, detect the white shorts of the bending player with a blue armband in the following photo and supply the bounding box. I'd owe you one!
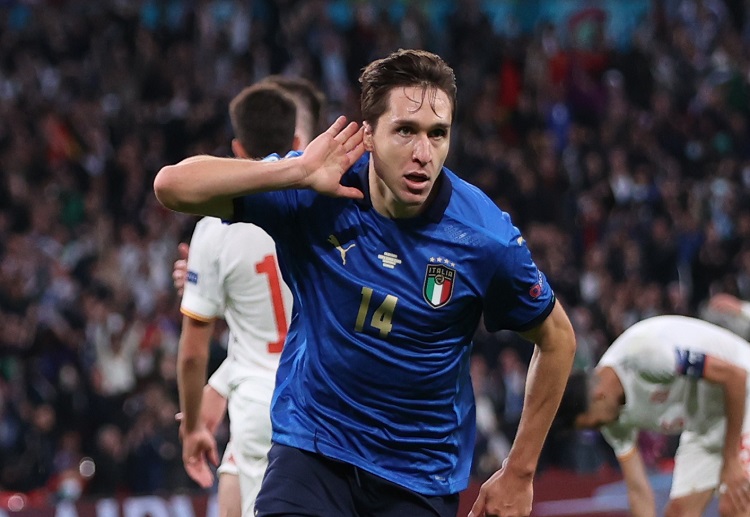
[669,390,750,499]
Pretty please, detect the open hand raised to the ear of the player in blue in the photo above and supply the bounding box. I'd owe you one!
[299,116,364,199]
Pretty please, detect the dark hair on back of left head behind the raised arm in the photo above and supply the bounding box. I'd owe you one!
[229,83,297,158]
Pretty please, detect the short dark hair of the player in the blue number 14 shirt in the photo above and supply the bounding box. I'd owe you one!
[359,49,457,127]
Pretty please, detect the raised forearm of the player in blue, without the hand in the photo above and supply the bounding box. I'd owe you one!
[154,156,305,218]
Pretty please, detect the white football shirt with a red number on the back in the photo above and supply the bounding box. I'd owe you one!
[180,217,292,394]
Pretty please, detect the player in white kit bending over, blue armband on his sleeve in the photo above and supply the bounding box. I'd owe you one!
[557,316,750,517]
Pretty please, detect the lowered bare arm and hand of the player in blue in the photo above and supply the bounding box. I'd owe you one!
[469,301,576,517]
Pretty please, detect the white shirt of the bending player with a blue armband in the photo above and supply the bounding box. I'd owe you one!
[599,316,750,456]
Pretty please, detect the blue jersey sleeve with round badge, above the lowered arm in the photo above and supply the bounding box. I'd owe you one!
[484,233,555,332]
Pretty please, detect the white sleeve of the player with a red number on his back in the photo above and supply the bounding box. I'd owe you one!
[180,220,224,321]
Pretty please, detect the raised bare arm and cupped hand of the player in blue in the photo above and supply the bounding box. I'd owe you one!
[154,117,364,219]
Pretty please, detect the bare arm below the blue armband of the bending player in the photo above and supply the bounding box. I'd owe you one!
[703,355,750,511]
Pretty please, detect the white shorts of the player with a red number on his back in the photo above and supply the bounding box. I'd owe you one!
[229,374,273,517]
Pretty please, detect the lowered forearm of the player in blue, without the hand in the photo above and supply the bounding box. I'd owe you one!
[507,304,576,475]
